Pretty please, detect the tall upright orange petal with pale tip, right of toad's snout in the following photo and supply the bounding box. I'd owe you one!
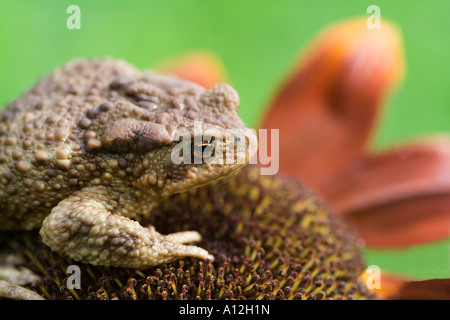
[261,19,403,187]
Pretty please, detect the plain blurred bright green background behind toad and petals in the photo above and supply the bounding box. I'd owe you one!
[0,0,450,279]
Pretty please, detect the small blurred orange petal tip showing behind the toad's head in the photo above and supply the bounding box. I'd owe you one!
[156,52,227,89]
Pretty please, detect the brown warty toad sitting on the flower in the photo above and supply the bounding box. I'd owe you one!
[0,59,256,269]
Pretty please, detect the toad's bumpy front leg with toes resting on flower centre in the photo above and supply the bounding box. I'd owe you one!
[40,188,213,269]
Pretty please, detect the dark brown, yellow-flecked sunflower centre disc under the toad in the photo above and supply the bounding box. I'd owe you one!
[3,166,372,300]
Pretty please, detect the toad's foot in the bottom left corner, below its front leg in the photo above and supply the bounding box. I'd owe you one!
[0,255,44,300]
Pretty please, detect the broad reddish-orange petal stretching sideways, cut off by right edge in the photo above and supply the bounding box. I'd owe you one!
[321,136,450,247]
